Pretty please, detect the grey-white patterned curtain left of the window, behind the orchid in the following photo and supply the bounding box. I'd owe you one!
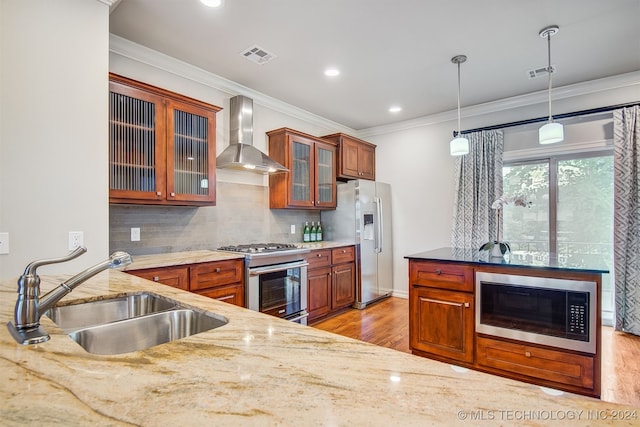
[451,130,504,250]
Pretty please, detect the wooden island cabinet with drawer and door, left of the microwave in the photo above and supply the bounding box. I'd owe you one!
[409,261,474,363]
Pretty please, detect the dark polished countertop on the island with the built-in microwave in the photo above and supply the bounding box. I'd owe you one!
[405,248,609,274]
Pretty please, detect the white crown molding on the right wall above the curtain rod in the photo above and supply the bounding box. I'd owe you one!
[356,71,640,138]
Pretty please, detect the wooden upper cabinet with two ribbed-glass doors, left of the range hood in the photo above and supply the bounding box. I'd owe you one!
[109,74,221,206]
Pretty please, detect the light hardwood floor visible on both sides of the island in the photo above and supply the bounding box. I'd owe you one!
[313,297,640,407]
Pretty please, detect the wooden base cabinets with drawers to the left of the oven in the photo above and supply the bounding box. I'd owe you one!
[127,259,245,307]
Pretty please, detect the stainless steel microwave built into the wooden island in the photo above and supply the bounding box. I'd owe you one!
[476,272,597,354]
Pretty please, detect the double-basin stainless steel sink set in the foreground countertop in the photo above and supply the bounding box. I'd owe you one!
[45,292,229,355]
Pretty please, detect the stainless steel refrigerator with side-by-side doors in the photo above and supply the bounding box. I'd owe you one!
[321,179,393,309]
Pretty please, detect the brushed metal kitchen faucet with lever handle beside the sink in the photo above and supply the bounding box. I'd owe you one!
[7,246,132,345]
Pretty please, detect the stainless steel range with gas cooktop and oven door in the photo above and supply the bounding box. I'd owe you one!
[219,243,309,325]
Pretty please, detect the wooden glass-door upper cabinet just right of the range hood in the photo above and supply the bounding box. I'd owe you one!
[267,128,336,209]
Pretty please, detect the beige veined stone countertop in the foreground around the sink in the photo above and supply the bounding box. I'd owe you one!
[0,270,639,426]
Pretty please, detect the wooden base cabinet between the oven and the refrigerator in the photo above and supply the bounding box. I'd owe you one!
[307,246,356,322]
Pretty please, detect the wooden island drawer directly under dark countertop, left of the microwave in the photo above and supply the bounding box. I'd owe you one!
[409,261,474,292]
